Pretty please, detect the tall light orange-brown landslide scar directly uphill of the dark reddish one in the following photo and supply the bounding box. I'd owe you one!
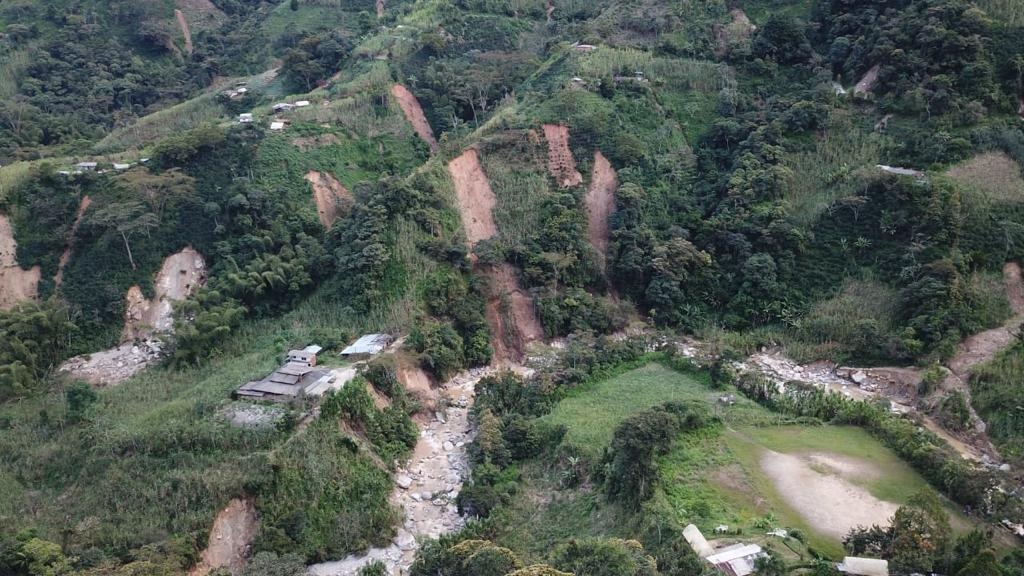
[449,149,498,243]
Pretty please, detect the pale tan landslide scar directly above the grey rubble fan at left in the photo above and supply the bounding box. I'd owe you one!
[121,248,206,342]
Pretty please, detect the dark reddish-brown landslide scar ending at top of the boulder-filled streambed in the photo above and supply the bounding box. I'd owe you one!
[477,262,544,365]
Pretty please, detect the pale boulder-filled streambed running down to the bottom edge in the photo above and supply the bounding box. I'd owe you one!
[309,369,493,576]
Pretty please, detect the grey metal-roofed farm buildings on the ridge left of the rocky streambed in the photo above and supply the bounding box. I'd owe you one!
[234,334,392,402]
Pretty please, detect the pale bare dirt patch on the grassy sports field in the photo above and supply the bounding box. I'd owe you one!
[760,450,899,540]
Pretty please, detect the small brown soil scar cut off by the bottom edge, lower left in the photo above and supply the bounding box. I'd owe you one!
[189,498,259,576]
